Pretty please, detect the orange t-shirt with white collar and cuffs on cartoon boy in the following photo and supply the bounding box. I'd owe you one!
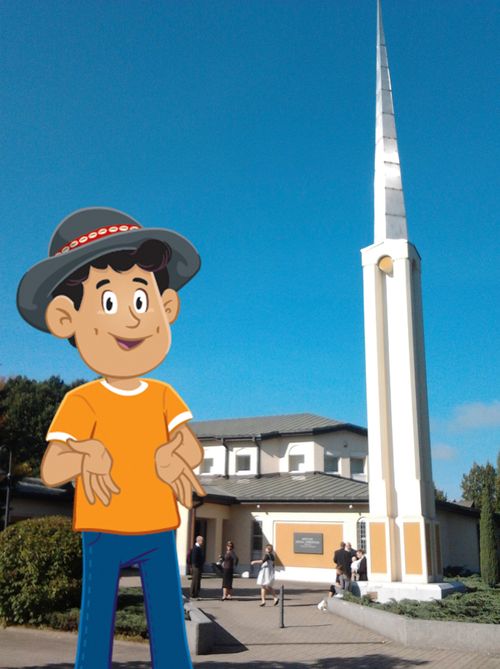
[47,379,192,534]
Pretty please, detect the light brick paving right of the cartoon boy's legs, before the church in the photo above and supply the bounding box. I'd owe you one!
[189,579,500,669]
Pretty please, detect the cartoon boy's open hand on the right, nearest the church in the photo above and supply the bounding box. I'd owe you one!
[155,432,207,509]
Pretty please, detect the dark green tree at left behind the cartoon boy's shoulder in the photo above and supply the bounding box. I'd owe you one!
[0,376,86,475]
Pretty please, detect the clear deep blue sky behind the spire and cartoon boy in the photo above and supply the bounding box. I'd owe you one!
[0,0,500,498]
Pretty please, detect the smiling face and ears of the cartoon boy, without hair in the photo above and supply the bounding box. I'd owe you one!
[45,266,179,378]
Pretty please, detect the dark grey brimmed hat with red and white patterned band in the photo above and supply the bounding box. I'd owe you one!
[17,207,200,332]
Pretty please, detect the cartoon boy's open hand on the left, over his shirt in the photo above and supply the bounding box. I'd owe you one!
[67,439,120,506]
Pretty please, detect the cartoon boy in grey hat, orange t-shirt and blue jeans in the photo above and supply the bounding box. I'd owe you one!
[17,207,205,669]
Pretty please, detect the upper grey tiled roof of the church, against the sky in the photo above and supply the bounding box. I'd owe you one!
[190,413,366,439]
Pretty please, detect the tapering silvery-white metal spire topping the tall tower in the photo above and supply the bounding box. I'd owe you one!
[374,0,408,243]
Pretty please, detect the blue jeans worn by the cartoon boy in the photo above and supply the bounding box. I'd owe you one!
[75,531,192,669]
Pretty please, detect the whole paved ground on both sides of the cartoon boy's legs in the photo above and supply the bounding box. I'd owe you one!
[0,579,500,669]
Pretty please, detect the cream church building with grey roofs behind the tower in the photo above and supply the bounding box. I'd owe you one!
[169,413,484,582]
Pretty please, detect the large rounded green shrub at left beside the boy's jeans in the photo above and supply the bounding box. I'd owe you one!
[0,516,82,624]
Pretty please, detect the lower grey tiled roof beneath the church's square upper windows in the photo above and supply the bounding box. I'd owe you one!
[200,472,368,503]
